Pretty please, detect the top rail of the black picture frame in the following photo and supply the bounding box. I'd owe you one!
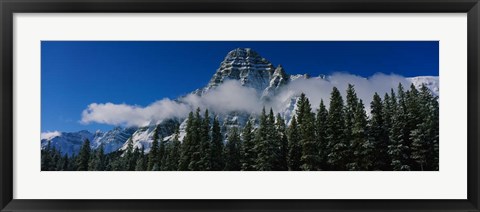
[2,0,477,13]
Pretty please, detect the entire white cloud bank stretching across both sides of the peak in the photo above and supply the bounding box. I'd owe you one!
[80,73,416,126]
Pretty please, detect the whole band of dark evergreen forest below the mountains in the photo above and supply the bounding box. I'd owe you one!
[41,84,439,171]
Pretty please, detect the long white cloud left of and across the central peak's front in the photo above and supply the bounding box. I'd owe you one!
[80,81,261,126]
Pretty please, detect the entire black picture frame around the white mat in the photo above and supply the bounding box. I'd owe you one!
[0,0,480,211]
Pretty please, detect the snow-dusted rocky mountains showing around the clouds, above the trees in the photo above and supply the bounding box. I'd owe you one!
[41,48,439,155]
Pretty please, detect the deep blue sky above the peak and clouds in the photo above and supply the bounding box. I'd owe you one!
[41,41,439,132]
